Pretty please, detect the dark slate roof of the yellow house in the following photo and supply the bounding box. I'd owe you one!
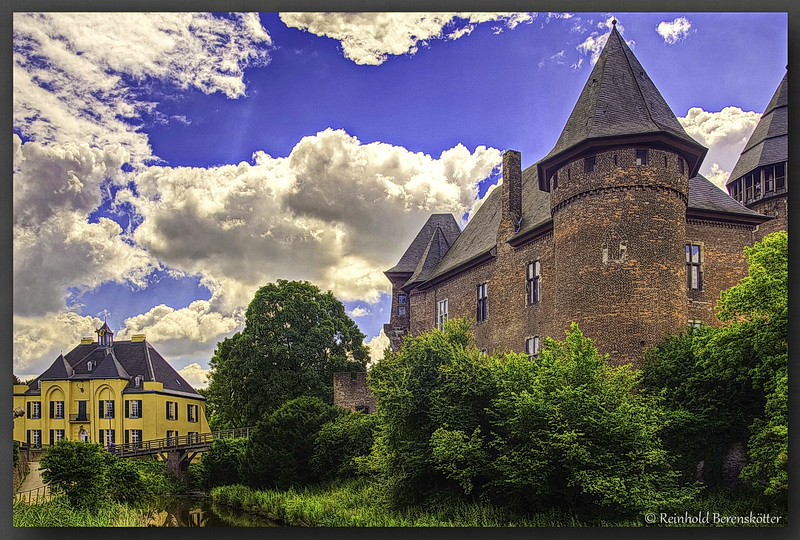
[26,334,205,399]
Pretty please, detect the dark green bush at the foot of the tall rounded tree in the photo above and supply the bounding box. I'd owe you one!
[239,396,345,489]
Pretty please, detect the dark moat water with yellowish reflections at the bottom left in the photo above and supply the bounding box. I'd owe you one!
[148,496,279,527]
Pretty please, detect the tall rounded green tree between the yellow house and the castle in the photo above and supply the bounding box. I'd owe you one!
[206,280,368,429]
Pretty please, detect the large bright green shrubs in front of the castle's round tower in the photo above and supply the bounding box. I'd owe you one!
[369,320,696,515]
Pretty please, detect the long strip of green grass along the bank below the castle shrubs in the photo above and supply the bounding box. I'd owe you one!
[210,478,787,527]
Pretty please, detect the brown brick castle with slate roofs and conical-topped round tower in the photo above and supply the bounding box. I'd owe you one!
[384,22,788,366]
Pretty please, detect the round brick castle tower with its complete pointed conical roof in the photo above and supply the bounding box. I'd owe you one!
[537,25,706,365]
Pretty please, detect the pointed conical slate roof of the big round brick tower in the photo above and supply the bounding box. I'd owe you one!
[537,23,707,191]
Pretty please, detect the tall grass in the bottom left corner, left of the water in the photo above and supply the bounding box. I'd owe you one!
[13,497,147,527]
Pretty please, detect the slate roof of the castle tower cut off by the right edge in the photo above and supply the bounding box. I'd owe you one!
[728,73,789,184]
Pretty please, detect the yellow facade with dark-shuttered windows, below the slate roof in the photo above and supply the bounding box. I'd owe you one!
[14,379,210,446]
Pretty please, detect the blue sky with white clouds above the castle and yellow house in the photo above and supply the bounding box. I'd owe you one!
[12,12,788,387]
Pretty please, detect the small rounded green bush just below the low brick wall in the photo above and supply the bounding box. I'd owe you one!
[310,412,376,480]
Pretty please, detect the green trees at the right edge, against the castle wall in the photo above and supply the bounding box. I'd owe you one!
[644,231,788,496]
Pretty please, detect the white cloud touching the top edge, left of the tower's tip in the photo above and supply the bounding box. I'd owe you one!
[280,12,536,65]
